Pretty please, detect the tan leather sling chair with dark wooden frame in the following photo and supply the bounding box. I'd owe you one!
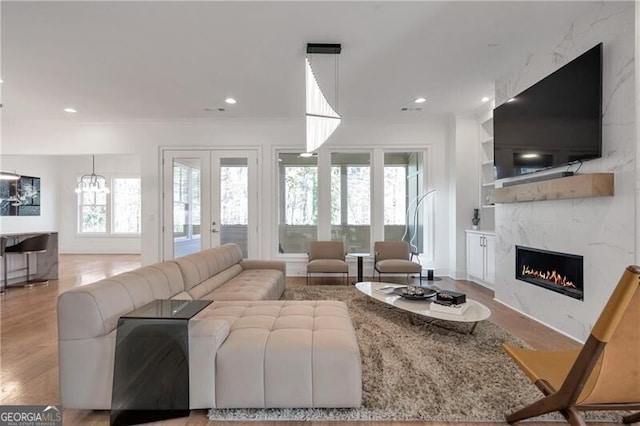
[503,266,640,425]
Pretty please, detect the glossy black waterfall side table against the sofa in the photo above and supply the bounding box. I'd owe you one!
[111,299,211,425]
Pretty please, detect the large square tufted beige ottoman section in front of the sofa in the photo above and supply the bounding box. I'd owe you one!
[196,301,362,408]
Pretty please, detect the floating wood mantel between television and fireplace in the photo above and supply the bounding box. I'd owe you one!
[489,173,613,203]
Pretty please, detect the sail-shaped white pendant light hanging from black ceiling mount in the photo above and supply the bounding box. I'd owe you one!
[305,43,342,153]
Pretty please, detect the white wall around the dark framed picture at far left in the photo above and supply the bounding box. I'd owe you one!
[0,155,59,234]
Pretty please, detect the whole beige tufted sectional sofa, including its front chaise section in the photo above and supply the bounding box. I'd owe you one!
[58,244,362,410]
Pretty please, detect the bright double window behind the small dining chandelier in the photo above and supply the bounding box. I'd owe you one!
[78,178,141,235]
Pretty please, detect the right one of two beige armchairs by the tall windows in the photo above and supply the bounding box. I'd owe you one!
[373,241,422,282]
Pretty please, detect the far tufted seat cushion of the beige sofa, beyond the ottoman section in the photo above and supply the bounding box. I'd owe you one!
[198,269,284,300]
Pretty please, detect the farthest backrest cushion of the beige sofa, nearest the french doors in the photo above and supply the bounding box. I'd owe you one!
[174,244,242,292]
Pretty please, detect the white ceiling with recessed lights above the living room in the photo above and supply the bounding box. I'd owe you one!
[0,1,599,121]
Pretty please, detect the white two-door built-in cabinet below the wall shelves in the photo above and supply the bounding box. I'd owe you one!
[466,231,496,290]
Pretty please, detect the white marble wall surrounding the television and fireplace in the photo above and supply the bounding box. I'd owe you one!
[495,2,637,340]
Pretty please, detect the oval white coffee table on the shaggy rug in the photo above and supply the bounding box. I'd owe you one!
[356,281,491,334]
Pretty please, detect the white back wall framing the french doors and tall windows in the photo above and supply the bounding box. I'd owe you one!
[2,116,449,270]
